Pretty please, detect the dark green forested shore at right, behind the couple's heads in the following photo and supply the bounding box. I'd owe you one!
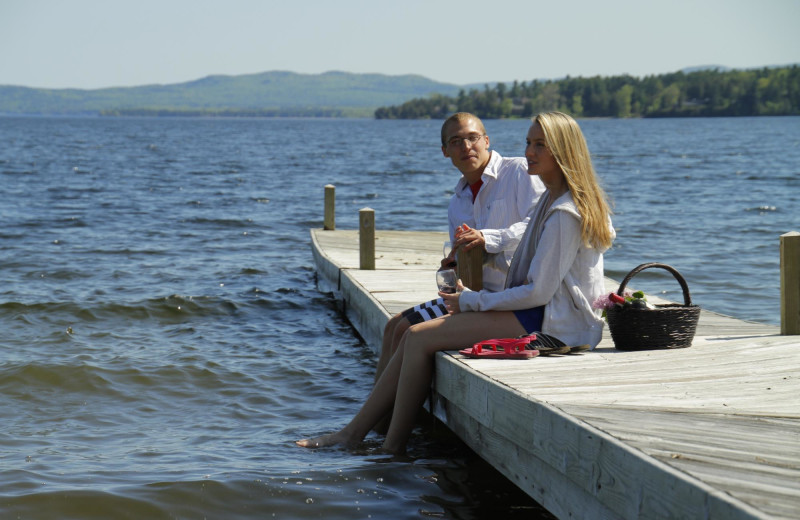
[375,65,800,119]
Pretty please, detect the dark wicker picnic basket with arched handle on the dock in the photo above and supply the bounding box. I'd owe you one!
[606,262,700,350]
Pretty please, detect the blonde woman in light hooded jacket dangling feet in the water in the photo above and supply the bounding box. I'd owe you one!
[297,112,614,453]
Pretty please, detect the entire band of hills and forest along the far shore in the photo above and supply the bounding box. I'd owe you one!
[0,65,800,120]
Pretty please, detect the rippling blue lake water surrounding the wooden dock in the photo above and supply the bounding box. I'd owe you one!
[0,117,800,519]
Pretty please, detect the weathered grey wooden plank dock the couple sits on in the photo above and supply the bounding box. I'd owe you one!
[311,230,800,520]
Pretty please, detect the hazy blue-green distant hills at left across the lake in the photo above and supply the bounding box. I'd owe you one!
[0,71,459,117]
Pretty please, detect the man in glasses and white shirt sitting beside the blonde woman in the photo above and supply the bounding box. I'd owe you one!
[375,112,545,380]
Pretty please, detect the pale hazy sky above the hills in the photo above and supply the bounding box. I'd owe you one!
[0,0,800,89]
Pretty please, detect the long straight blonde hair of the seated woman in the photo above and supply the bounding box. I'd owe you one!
[533,112,613,249]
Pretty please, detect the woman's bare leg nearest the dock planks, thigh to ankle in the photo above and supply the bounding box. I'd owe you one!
[383,312,526,453]
